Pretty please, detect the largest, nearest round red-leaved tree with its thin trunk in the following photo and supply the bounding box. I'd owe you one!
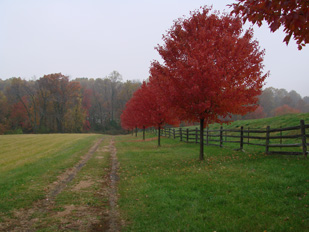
[153,7,267,160]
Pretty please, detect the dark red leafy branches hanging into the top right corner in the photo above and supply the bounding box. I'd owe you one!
[231,0,309,50]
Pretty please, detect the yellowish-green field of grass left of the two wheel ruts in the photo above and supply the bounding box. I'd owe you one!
[0,134,100,214]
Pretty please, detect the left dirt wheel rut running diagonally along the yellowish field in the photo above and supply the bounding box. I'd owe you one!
[0,138,104,231]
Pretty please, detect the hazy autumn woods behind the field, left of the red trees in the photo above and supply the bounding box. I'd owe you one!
[0,71,141,134]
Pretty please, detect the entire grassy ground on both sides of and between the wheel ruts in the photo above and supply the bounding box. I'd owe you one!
[0,118,309,232]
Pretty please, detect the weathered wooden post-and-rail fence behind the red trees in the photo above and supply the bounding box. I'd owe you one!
[161,120,309,156]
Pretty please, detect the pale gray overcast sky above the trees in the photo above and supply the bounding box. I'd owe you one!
[0,0,309,96]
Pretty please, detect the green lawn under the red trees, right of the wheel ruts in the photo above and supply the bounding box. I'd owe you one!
[116,135,309,231]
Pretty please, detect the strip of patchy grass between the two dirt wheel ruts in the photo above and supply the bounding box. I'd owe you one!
[31,136,111,232]
